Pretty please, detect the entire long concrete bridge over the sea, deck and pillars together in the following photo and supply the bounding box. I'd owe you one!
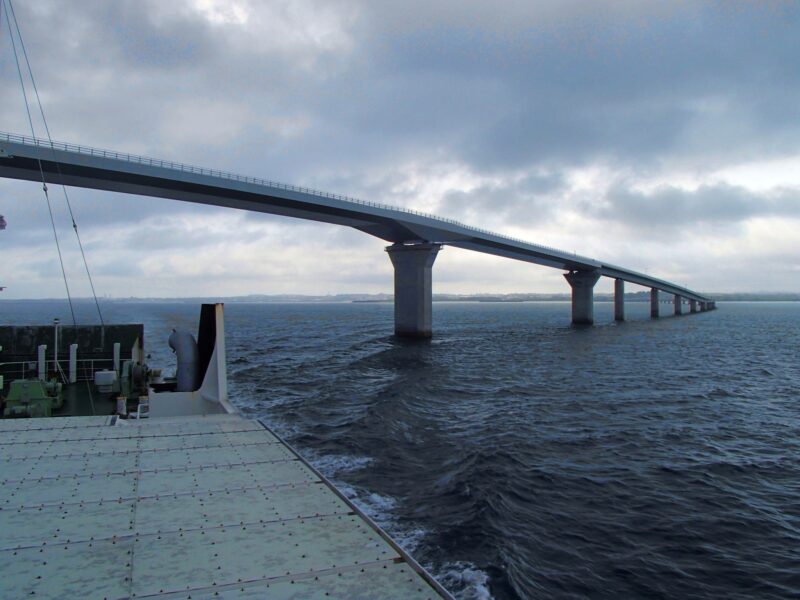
[0,133,715,337]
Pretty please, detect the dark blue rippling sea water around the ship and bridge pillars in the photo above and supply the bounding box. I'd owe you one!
[0,302,800,598]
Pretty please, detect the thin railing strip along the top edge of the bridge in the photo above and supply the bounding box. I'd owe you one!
[0,132,598,263]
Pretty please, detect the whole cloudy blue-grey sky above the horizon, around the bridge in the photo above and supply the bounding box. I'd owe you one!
[0,0,800,298]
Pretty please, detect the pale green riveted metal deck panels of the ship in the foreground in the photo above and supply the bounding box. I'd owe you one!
[0,415,448,599]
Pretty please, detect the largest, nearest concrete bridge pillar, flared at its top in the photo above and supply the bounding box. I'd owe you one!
[386,243,441,338]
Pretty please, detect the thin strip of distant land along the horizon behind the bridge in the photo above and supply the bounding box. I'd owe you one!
[0,291,800,304]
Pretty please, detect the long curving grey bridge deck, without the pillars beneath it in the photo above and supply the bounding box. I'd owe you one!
[0,133,709,301]
